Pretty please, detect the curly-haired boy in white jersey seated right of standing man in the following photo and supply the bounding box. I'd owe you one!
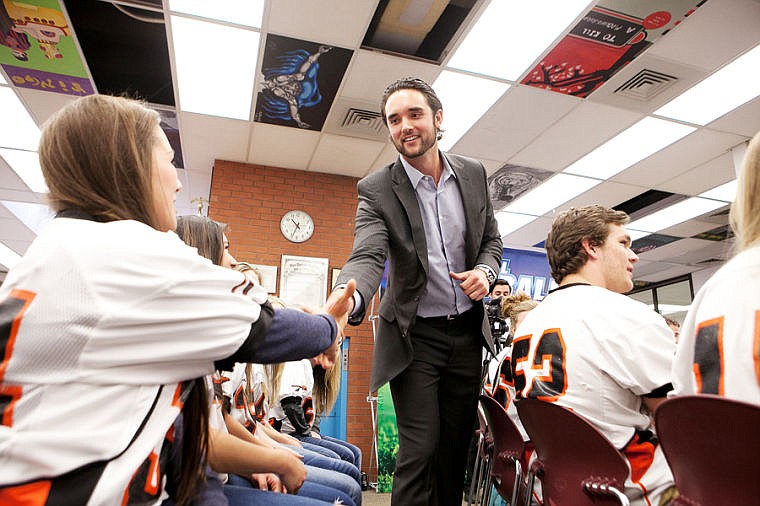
[512,205,675,505]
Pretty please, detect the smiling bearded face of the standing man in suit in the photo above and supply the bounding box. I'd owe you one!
[385,90,443,159]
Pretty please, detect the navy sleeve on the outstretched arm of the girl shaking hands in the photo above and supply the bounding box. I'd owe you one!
[216,303,338,371]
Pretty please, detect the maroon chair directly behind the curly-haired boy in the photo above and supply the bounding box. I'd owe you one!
[516,399,630,506]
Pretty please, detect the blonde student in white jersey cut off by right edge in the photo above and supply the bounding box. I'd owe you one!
[673,129,760,404]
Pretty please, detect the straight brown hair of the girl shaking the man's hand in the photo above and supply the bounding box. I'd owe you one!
[39,95,160,228]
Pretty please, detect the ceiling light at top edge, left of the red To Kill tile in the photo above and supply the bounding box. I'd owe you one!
[447,0,589,81]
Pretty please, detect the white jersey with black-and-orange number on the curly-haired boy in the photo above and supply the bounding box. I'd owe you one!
[512,285,675,505]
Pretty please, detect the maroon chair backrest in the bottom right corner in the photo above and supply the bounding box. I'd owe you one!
[655,395,760,506]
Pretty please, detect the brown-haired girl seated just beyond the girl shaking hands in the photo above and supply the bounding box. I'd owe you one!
[177,215,361,505]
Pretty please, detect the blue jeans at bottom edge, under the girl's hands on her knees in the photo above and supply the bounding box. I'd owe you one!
[224,468,356,506]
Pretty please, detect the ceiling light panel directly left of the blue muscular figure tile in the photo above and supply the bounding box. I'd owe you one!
[171,16,260,121]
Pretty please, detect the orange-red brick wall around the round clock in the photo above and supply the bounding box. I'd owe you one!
[208,160,373,471]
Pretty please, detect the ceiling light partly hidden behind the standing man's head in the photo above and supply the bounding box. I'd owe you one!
[433,71,509,151]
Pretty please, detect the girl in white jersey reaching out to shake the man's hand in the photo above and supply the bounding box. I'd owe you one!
[0,95,348,505]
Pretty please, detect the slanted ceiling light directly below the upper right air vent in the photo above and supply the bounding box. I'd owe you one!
[562,117,696,179]
